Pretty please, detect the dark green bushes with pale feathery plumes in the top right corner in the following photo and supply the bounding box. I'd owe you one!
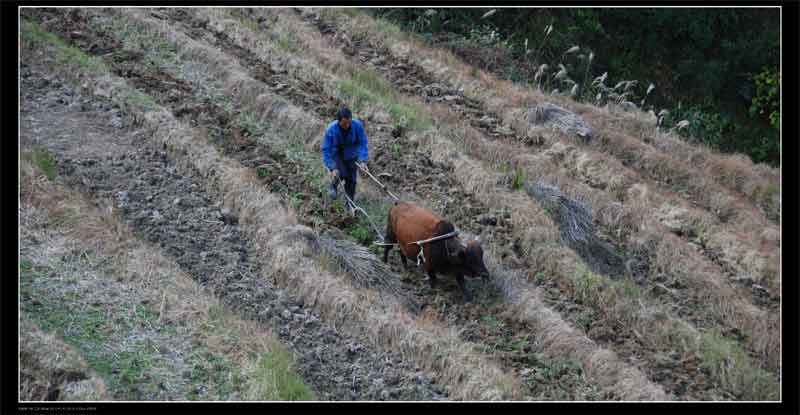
[371,8,780,165]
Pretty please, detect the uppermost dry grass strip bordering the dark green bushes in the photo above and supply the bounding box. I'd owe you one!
[310,9,780,228]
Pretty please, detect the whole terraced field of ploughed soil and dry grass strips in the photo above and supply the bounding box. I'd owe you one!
[20,8,781,401]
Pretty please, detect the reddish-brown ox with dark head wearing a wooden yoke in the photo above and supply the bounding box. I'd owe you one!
[383,202,489,302]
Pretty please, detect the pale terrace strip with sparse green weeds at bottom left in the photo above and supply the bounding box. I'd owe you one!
[19,249,314,400]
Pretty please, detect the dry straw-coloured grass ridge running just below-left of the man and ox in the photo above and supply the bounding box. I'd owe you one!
[148,104,519,400]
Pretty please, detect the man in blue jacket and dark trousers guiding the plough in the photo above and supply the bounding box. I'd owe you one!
[321,107,369,214]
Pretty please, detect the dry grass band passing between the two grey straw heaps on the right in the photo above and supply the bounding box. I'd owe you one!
[440,110,780,295]
